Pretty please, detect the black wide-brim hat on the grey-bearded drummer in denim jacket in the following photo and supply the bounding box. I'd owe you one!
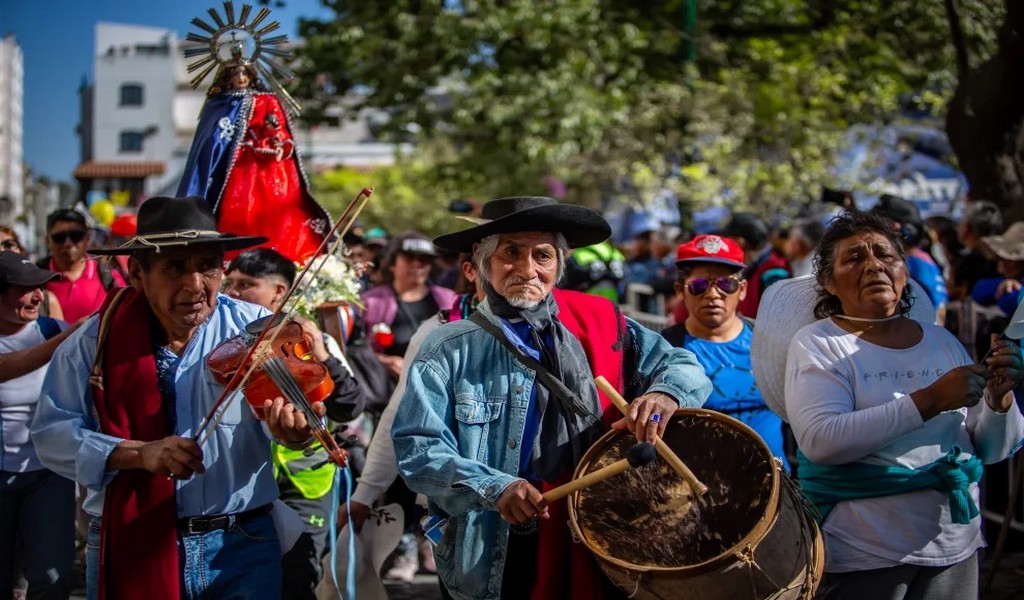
[434,196,611,252]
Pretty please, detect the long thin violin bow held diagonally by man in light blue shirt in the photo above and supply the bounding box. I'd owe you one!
[197,187,374,447]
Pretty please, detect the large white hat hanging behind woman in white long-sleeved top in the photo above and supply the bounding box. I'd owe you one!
[751,275,935,423]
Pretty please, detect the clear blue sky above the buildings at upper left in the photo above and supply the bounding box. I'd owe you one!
[0,0,334,181]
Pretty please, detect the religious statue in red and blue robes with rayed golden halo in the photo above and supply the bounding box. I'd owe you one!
[177,1,331,262]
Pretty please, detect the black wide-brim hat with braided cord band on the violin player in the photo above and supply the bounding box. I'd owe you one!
[89,196,268,256]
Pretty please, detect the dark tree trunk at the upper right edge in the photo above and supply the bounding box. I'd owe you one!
[946,0,1024,222]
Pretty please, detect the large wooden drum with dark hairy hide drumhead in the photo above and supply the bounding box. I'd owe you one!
[568,409,824,600]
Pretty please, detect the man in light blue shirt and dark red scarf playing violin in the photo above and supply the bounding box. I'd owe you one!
[32,198,324,600]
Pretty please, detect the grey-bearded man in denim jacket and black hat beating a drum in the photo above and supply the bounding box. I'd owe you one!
[391,197,711,600]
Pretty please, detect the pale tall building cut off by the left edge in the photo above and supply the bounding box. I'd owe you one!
[0,34,25,225]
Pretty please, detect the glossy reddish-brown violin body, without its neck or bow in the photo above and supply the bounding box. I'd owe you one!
[206,317,334,421]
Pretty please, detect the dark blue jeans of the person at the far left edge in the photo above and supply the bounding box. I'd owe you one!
[0,469,75,599]
